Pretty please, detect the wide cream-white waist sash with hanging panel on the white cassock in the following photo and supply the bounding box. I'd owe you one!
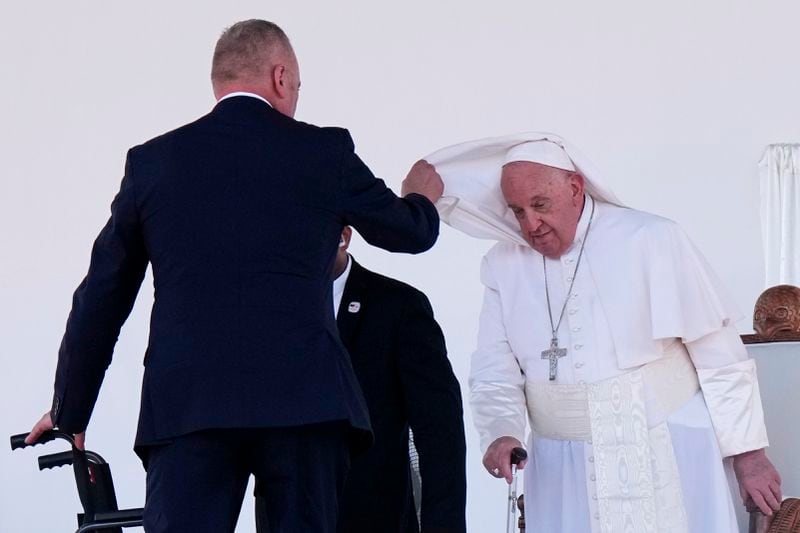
[525,341,700,533]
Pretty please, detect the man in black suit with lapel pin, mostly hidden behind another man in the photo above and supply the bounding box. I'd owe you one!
[256,227,466,533]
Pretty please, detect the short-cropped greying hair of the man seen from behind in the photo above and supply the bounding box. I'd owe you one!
[211,19,292,85]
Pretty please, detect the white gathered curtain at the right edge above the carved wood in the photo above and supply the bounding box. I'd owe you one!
[759,144,800,287]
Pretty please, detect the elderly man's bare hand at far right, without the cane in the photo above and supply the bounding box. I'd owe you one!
[733,449,783,516]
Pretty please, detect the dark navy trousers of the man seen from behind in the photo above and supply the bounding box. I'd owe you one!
[144,422,350,533]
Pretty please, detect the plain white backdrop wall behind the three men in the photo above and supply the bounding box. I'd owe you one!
[0,0,800,533]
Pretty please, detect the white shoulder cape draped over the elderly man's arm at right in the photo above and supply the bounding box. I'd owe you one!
[556,202,740,369]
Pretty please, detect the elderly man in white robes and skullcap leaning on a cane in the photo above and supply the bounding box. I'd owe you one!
[426,134,781,533]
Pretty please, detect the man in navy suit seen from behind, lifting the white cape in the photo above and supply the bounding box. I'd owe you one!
[28,20,441,533]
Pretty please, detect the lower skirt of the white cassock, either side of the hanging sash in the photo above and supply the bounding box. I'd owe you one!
[522,393,738,533]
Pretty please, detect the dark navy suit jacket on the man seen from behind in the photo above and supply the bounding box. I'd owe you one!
[51,96,439,449]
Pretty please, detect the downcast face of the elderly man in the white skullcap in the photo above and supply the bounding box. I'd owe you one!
[500,161,584,259]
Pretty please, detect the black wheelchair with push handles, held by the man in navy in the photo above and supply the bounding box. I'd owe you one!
[11,431,143,533]
